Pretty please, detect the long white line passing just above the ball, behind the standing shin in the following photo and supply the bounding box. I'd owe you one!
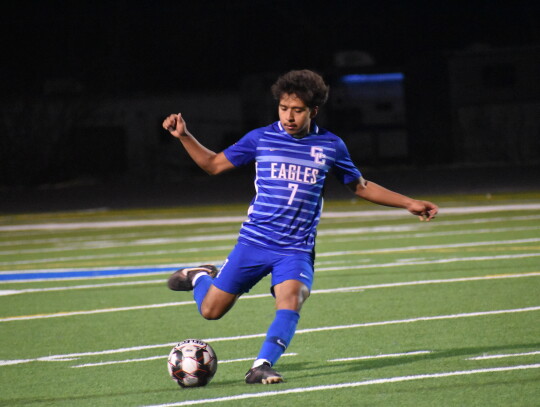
[0,306,540,366]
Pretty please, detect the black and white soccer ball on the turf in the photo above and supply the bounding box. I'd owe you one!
[167,339,217,387]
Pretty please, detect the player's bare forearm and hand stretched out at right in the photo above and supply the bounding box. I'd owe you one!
[347,177,439,221]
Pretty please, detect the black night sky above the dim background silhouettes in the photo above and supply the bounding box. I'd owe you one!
[0,0,540,94]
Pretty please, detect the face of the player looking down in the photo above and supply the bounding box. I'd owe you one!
[278,93,317,137]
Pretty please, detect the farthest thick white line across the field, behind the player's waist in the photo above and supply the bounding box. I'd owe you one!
[0,204,540,231]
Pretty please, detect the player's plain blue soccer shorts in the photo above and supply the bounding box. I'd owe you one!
[213,243,314,294]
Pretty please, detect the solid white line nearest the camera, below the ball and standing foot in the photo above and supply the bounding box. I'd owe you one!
[139,363,540,407]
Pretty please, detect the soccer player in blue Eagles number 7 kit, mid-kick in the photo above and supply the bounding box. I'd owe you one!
[163,70,438,384]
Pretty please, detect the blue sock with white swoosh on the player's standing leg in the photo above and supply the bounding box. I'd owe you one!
[257,309,300,365]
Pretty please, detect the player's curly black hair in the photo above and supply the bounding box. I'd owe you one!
[271,69,330,108]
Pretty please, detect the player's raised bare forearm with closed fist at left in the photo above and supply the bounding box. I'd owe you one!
[163,113,234,175]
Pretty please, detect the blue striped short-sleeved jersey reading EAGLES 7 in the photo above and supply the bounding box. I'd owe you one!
[224,122,361,252]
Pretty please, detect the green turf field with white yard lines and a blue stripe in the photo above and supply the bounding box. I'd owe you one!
[0,193,540,407]
